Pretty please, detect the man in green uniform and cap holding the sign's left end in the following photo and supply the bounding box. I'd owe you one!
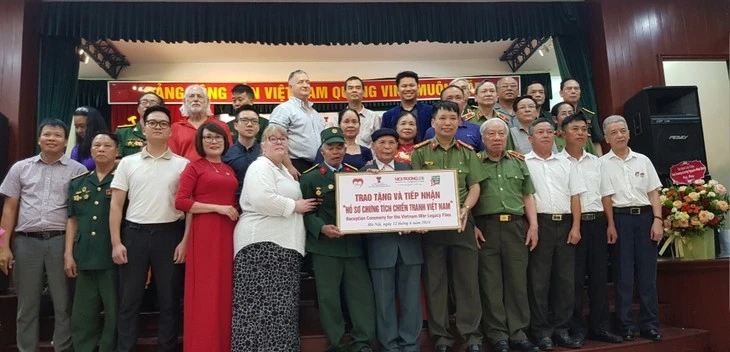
[299,127,375,352]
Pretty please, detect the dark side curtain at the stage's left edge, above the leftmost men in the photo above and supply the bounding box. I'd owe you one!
[37,36,79,129]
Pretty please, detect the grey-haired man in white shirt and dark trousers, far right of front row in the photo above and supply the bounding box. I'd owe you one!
[601,115,664,341]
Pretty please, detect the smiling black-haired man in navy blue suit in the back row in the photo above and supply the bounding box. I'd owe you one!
[381,71,432,141]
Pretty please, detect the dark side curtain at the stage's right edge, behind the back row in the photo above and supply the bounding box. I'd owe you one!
[553,35,597,111]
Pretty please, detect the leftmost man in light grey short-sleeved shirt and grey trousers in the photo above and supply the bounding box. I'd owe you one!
[0,120,86,351]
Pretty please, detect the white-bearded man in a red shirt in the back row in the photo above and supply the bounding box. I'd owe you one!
[167,84,233,161]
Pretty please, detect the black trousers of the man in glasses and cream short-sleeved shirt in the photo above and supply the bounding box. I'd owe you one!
[117,221,185,352]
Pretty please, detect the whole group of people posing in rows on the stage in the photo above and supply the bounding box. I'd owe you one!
[0,70,663,352]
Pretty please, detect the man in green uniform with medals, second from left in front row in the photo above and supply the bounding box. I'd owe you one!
[64,133,119,352]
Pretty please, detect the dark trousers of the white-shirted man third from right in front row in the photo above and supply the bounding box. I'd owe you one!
[527,214,575,339]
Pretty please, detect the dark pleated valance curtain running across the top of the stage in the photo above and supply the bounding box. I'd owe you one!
[41,2,583,45]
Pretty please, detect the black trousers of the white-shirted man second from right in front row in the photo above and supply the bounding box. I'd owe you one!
[570,216,609,335]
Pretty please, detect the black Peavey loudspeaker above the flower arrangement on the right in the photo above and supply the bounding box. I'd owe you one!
[624,86,709,179]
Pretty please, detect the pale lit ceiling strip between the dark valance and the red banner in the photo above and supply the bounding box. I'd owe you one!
[79,41,558,79]
